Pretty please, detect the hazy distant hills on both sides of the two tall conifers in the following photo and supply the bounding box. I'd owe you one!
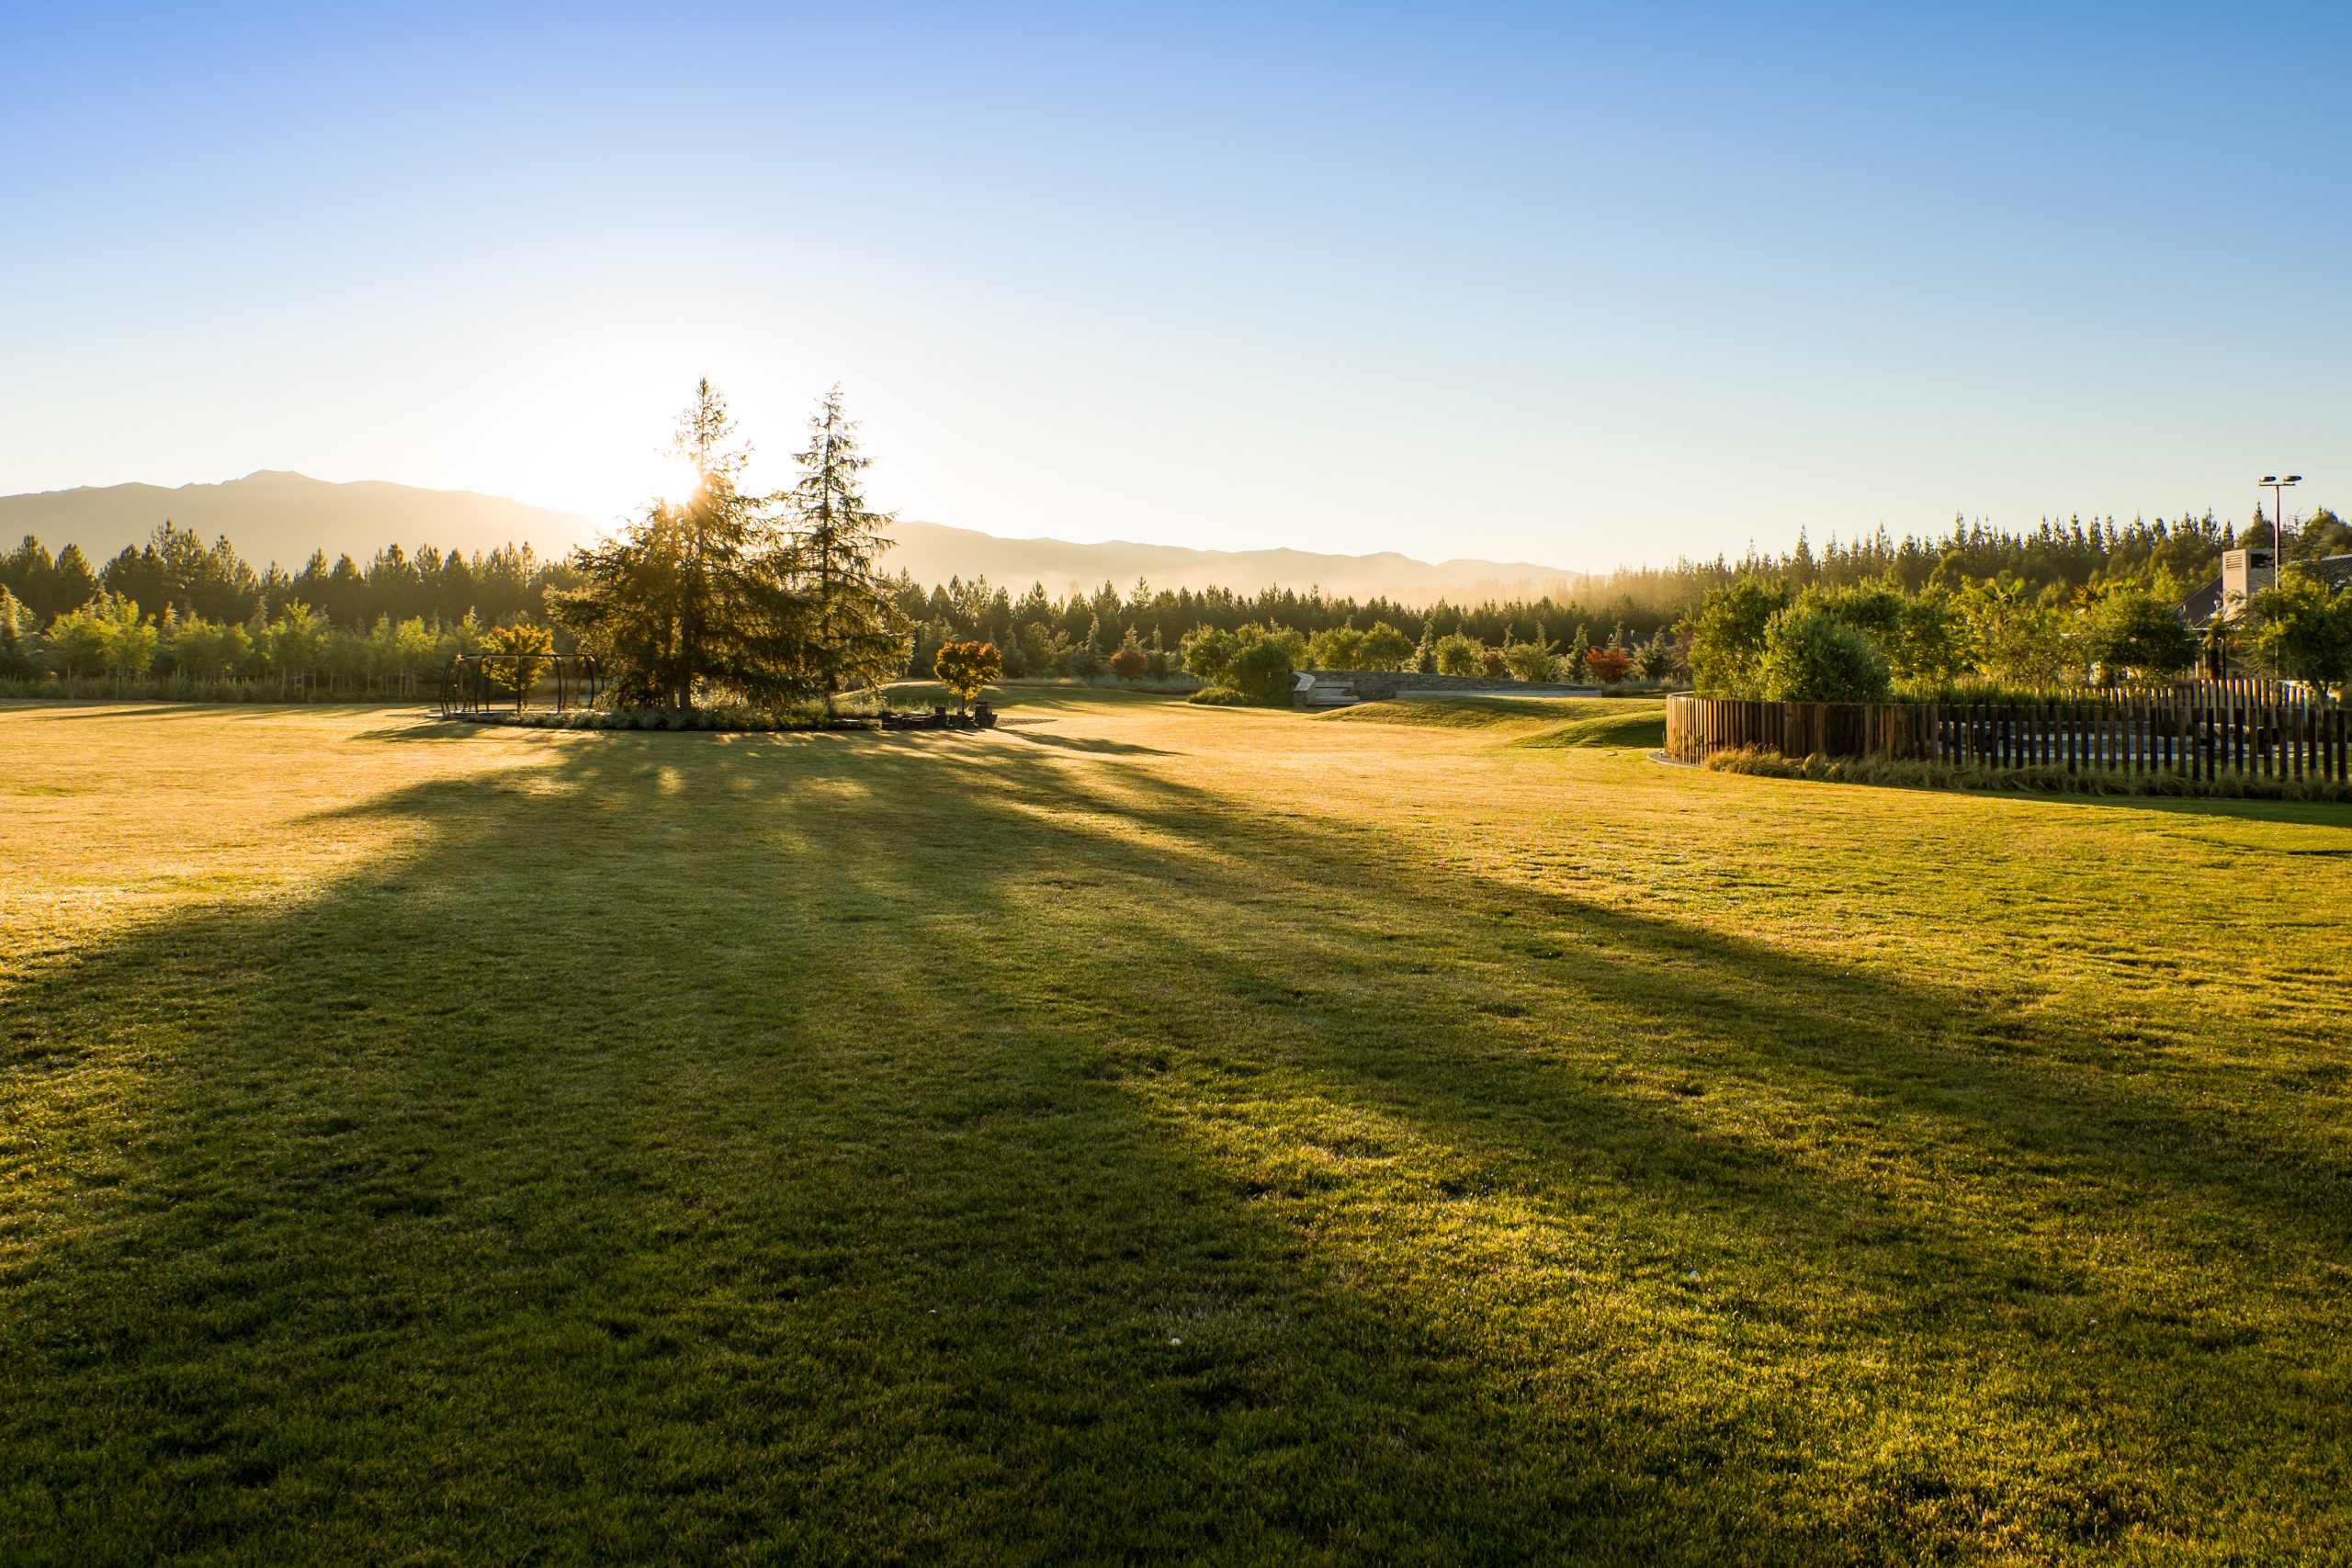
[0,470,1580,604]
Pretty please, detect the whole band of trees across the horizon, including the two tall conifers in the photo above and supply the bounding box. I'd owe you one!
[0,423,2352,705]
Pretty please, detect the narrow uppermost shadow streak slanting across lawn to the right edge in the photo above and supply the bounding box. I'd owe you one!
[1105,757,2352,1246]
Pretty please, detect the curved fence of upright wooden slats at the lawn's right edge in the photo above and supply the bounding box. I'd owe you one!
[1665,680,2352,783]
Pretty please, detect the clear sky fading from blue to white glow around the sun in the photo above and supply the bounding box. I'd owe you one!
[0,3,2352,567]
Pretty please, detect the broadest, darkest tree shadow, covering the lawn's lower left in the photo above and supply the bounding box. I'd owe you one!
[0,736,1731,1561]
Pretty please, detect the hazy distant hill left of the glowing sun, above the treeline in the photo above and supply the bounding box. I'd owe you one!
[0,470,595,582]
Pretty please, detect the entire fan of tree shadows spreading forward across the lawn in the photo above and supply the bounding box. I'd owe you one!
[0,733,2345,1561]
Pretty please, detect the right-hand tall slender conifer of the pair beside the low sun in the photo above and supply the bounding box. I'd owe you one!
[788,386,908,710]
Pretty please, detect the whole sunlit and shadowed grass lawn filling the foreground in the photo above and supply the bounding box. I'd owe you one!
[0,694,2352,1563]
